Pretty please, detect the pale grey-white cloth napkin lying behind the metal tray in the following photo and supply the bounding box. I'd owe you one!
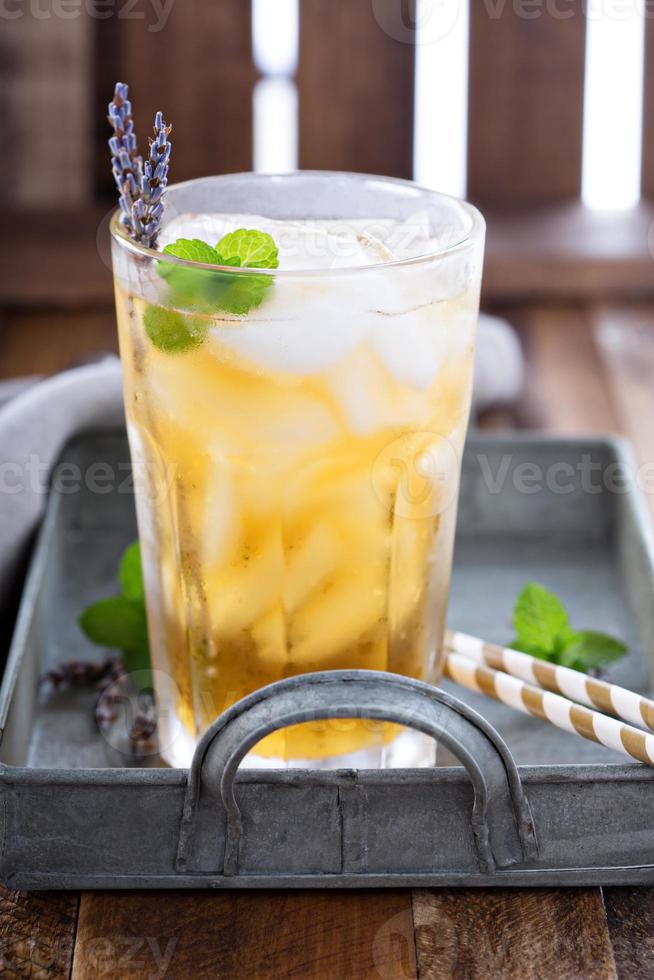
[0,315,523,607]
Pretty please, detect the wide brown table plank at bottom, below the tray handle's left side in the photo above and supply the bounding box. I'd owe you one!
[72,891,415,980]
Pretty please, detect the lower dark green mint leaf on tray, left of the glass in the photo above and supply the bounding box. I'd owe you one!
[79,595,150,672]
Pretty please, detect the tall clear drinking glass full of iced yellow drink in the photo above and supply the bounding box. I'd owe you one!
[112,172,484,766]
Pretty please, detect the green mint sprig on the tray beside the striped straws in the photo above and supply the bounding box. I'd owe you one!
[511,582,627,672]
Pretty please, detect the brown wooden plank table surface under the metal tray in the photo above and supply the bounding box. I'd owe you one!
[0,304,654,980]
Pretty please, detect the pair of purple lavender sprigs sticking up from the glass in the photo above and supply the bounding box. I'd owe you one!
[107,82,171,248]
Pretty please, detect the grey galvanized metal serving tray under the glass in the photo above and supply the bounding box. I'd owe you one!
[0,433,654,888]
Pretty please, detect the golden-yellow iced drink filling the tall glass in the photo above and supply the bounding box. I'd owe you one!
[110,172,478,765]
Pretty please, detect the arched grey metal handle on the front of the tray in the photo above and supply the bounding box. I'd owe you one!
[177,670,537,875]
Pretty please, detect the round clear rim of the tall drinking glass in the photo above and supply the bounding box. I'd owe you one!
[109,170,485,279]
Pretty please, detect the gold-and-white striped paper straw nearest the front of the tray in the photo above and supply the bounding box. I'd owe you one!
[445,653,654,766]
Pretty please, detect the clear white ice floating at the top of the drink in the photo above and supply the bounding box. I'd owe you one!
[162,212,472,388]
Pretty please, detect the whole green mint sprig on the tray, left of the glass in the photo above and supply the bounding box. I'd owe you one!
[78,541,150,673]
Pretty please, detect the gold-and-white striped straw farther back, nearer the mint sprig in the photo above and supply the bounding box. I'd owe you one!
[445,630,654,731]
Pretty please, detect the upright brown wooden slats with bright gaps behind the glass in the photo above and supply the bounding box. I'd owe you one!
[0,0,654,209]
